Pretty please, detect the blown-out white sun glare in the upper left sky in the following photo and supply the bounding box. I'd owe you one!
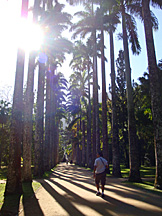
[0,0,44,52]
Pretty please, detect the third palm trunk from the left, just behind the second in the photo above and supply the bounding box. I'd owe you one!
[34,62,45,176]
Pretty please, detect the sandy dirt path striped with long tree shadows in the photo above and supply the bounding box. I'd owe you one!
[19,163,162,216]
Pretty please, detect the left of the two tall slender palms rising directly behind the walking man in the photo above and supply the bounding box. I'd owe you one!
[71,3,100,159]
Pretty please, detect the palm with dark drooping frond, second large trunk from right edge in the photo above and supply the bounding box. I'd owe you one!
[114,0,141,182]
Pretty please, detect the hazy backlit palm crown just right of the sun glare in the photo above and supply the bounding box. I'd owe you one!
[40,3,72,63]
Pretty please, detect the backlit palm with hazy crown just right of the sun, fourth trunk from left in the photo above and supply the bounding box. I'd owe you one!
[35,1,71,174]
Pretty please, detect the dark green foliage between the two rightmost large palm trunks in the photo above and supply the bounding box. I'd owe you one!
[134,72,155,166]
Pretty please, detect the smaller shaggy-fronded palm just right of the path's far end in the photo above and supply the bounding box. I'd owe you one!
[67,67,91,165]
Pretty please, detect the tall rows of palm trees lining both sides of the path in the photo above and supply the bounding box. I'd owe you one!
[1,0,162,194]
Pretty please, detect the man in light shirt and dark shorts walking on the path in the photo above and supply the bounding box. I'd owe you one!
[93,151,108,197]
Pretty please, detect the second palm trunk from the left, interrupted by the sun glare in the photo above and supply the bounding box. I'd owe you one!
[23,0,40,181]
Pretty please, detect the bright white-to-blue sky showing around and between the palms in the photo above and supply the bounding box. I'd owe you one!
[0,0,162,101]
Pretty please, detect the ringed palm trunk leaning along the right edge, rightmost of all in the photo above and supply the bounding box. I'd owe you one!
[142,0,162,189]
